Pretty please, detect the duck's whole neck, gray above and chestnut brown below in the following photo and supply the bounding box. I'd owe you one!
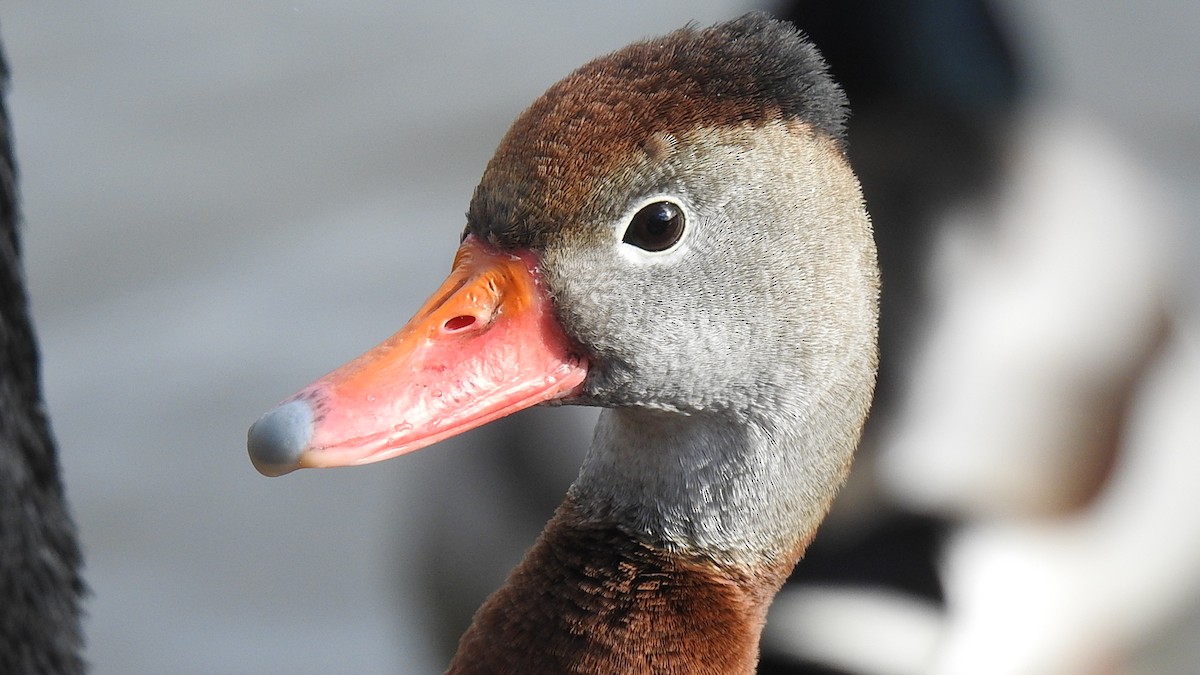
[450,410,854,674]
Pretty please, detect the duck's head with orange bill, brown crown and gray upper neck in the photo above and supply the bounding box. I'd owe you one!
[248,9,878,562]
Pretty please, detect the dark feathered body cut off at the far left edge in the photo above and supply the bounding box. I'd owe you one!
[0,45,88,675]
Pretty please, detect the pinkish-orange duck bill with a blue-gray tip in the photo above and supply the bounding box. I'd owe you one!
[248,237,587,476]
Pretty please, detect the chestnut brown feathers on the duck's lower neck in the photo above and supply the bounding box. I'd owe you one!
[449,500,794,675]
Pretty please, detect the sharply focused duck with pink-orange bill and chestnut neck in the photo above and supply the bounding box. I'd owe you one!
[247,12,880,674]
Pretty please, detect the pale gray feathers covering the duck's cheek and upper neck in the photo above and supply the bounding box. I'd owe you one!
[545,123,877,557]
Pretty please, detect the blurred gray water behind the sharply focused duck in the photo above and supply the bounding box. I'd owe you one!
[0,0,1200,674]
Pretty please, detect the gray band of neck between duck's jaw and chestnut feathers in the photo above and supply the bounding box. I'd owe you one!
[571,408,857,566]
